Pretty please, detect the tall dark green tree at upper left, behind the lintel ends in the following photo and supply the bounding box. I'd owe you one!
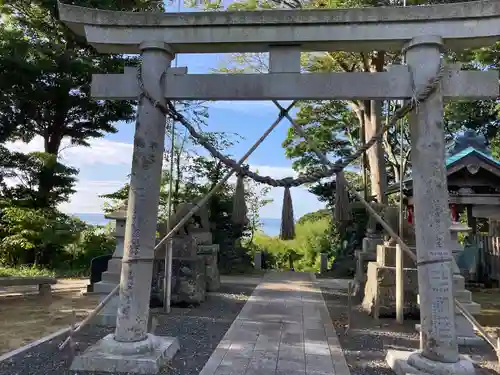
[0,0,164,207]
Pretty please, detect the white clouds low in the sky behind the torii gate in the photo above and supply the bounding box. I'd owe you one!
[7,138,324,218]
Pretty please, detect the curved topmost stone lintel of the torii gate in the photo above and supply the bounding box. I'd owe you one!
[58,0,500,53]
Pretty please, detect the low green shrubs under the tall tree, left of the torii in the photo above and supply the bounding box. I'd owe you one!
[0,206,115,276]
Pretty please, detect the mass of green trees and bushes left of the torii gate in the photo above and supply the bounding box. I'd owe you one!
[0,0,158,267]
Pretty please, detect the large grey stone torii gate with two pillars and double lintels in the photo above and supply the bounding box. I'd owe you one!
[59,0,500,375]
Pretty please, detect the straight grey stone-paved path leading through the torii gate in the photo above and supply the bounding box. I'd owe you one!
[200,272,350,375]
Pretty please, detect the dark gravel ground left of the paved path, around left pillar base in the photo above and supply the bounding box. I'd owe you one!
[0,283,254,375]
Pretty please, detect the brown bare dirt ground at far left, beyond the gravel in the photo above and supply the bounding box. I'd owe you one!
[0,290,99,354]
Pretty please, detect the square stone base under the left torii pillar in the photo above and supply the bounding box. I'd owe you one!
[70,334,179,374]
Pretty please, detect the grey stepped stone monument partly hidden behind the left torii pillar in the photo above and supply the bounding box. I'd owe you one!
[93,201,127,327]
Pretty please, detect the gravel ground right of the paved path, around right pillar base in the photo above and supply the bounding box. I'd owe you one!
[321,288,499,375]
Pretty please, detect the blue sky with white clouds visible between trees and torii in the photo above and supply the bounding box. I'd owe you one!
[5,0,323,218]
